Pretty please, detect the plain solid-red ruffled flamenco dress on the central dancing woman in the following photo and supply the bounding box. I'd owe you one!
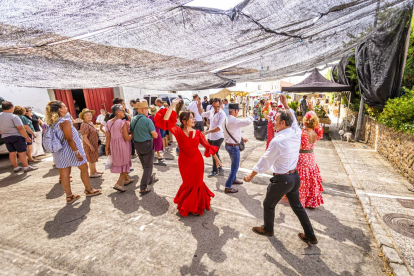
[155,109,218,217]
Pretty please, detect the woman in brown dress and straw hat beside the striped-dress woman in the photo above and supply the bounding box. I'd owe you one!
[79,108,103,178]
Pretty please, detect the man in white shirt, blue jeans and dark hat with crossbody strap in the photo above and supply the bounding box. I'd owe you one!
[224,104,254,193]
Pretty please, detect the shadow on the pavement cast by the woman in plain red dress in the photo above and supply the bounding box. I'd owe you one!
[180,209,239,275]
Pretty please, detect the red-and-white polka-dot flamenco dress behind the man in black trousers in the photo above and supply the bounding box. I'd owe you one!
[296,125,323,208]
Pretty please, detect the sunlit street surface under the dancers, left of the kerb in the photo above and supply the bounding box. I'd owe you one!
[0,127,389,275]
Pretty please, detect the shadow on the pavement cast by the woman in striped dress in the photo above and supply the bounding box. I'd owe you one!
[43,197,91,239]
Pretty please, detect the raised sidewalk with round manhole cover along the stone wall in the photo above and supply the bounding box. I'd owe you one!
[333,136,414,275]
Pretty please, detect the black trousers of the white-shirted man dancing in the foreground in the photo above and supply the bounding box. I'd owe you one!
[263,171,315,238]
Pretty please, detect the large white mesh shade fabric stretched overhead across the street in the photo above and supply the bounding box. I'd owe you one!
[0,0,412,90]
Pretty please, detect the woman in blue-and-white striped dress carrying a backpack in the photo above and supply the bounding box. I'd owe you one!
[46,101,102,203]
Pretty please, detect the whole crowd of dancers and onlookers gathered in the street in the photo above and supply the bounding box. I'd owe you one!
[0,94,323,243]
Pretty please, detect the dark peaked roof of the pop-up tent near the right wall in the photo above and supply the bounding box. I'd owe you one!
[282,68,352,93]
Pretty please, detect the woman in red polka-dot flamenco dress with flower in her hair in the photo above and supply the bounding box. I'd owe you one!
[296,111,323,208]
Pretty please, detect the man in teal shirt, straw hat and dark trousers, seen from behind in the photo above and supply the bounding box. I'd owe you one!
[130,102,158,195]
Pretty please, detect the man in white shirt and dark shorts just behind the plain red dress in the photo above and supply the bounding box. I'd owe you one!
[201,98,226,177]
